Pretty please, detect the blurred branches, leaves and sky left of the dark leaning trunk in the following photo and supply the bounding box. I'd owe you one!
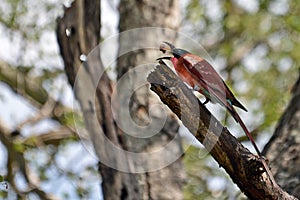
[0,0,100,199]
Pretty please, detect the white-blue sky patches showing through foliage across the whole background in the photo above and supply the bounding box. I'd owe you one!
[0,0,290,199]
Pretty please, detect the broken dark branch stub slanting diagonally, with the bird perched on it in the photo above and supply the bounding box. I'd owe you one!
[148,64,296,199]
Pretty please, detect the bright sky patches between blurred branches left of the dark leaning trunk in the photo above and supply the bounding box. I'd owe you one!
[0,0,103,199]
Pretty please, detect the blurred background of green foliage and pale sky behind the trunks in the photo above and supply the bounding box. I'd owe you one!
[0,0,300,199]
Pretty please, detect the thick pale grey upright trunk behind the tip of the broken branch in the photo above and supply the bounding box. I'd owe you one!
[117,0,185,199]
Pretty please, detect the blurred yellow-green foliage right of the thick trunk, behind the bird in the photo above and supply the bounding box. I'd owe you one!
[182,0,300,199]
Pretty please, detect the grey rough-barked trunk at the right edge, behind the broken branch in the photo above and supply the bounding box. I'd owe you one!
[263,74,300,198]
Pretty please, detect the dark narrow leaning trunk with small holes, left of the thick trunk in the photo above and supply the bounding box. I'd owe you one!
[57,0,138,200]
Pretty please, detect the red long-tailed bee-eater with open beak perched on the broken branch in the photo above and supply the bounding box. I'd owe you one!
[157,42,274,184]
